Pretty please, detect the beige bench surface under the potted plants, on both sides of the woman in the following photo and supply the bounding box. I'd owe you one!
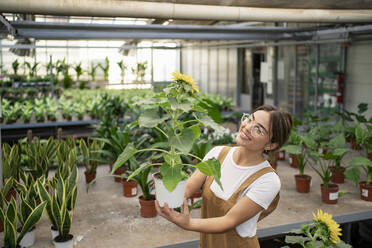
[0,147,372,248]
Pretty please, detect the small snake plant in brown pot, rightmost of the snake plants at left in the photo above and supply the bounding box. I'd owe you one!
[79,139,104,183]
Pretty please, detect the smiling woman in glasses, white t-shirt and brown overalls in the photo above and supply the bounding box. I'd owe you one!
[156,105,292,248]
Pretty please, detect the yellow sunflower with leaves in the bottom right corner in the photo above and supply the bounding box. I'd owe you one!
[282,209,352,248]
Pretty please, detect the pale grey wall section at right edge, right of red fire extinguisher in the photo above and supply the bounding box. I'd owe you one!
[344,42,372,118]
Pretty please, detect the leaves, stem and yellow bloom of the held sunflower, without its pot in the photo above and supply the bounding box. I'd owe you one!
[112,71,224,192]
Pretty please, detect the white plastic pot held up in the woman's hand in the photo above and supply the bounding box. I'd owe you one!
[152,173,187,208]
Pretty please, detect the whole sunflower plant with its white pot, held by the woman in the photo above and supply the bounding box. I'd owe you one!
[113,71,224,208]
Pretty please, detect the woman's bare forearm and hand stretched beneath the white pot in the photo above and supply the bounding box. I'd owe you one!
[155,196,263,233]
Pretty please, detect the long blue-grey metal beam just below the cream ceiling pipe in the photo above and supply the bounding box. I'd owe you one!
[2,21,315,40]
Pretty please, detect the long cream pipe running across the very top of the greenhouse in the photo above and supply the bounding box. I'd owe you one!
[0,0,372,23]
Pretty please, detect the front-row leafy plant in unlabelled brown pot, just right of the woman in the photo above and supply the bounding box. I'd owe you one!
[281,134,317,193]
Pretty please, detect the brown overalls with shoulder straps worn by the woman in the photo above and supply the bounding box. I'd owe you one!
[199,147,279,248]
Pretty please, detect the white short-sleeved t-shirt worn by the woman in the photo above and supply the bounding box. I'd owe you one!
[203,146,280,238]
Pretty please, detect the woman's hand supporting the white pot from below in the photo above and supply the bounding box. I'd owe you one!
[155,199,190,230]
